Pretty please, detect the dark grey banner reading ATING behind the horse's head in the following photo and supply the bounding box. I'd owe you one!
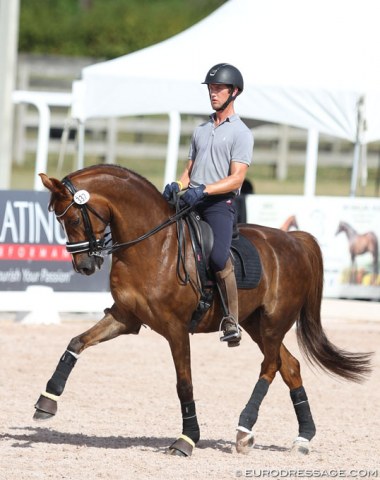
[0,191,110,292]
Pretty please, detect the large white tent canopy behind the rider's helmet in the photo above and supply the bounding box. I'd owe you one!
[73,0,380,193]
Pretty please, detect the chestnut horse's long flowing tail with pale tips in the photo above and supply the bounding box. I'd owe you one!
[297,232,372,382]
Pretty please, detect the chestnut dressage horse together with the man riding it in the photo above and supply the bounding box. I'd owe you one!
[33,64,371,456]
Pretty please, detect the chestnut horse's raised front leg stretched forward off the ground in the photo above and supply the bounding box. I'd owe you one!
[33,306,141,420]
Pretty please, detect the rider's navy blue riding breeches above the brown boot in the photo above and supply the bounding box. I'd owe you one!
[196,195,235,273]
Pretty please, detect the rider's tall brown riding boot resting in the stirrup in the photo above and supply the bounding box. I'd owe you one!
[215,258,241,347]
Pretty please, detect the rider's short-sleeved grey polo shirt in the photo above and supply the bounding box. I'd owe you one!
[189,114,253,193]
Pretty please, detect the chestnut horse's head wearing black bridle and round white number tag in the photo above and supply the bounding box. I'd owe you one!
[40,173,110,275]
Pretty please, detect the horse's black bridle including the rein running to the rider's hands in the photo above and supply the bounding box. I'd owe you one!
[55,177,192,257]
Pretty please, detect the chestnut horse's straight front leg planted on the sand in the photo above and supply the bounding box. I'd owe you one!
[168,330,200,457]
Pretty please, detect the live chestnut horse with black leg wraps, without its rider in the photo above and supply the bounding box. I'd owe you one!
[34,165,370,456]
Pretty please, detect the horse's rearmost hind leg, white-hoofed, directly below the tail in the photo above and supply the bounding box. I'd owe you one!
[280,344,316,454]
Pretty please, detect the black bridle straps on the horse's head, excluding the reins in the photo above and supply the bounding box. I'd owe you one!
[56,177,108,257]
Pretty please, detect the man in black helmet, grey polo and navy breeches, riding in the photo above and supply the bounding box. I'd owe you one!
[163,63,253,347]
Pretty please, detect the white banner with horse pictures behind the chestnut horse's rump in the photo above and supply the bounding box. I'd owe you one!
[246,195,380,300]
